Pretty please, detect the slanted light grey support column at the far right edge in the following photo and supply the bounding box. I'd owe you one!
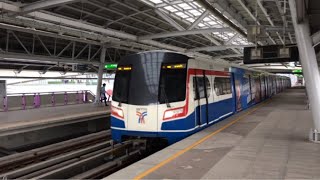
[289,0,320,142]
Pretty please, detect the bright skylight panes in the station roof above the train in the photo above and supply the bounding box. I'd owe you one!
[140,0,251,45]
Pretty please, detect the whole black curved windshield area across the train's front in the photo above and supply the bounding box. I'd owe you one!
[112,52,188,105]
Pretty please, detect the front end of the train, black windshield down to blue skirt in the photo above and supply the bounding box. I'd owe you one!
[111,51,189,142]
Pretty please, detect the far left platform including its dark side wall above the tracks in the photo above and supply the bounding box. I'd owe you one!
[0,104,110,149]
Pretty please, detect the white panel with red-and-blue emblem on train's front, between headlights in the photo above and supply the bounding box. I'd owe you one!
[128,105,157,131]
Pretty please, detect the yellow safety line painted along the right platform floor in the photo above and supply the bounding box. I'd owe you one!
[134,102,266,180]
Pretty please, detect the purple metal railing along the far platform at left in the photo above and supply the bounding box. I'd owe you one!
[0,90,95,111]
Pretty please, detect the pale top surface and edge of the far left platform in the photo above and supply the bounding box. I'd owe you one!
[0,103,110,136]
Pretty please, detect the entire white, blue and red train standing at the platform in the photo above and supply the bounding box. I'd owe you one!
[111,51,290,144]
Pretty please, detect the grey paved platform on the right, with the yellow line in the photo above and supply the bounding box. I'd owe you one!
[107,89,320,179]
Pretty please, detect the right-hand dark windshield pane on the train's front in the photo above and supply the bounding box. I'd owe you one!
[159,63,187,104]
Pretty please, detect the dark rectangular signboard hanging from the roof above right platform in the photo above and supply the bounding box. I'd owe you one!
[243,45,299,64]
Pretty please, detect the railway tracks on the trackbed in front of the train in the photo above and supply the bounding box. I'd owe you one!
[0,130,146,179]
